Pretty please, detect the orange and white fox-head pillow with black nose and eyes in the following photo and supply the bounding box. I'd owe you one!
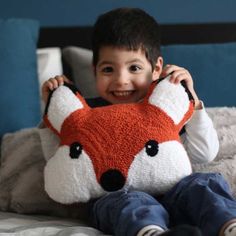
[44,77,193,204]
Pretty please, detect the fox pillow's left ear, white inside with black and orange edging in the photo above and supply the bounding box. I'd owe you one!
[44,84,89,133]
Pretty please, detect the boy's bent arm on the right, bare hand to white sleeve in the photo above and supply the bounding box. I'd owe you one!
[162,65,219,163]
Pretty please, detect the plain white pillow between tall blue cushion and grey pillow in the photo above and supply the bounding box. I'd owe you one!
[37,47,63,114]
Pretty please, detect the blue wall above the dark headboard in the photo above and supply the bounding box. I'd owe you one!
[0,0,236,26]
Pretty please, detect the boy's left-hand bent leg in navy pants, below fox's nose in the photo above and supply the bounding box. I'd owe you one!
[91,190,168,236]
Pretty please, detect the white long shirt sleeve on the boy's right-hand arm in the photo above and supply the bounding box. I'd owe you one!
[181,103,219,163]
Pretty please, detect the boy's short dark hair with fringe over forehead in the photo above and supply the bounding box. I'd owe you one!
[92,8,161,69]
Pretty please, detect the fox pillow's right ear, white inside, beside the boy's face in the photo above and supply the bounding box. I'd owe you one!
[148,76,193,125]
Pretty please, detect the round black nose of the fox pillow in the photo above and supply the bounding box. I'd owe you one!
[100,169,125,192]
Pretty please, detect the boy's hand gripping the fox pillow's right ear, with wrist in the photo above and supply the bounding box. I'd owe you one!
[161,65,202,109]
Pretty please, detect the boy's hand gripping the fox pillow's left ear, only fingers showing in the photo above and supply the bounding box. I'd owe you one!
[42,75,72,104]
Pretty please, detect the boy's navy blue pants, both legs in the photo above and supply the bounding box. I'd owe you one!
[91,173,236,236]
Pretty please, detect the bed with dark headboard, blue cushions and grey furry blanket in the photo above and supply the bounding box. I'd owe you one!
[0,19,236,236]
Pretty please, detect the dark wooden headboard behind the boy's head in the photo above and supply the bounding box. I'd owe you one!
[38,23,236,48]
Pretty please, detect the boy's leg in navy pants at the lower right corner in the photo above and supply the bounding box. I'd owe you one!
[161,173,236,236]
